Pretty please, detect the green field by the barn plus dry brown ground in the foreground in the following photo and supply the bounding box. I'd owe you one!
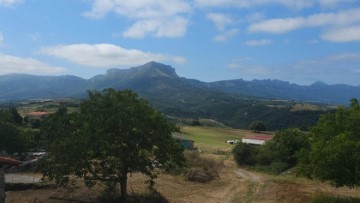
[6,127,360,203]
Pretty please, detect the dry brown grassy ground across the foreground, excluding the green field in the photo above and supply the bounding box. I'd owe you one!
[6,159,360,203]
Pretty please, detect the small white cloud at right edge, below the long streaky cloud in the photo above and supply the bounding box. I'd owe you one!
[321,25,360,42]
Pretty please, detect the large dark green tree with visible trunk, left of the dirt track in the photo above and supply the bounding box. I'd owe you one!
[43,89,184,201]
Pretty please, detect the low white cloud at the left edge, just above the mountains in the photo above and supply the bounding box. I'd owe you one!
[0,54,67,74]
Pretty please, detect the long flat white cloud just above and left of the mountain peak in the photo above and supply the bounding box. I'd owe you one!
[40,44,186,67]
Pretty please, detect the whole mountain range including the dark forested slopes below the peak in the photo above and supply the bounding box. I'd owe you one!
[0,62,360,130]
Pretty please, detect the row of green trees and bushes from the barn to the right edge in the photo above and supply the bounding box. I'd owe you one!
[233,99,360,187]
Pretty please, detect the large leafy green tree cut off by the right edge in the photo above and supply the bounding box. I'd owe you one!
[299,99,360,187]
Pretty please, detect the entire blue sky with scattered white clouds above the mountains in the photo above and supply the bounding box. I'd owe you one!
[0,0,360,86]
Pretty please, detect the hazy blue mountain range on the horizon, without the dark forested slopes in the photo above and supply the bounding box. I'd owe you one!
[0,62,360,104]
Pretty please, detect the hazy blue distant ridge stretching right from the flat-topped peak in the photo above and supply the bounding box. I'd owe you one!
[185,79,360,104]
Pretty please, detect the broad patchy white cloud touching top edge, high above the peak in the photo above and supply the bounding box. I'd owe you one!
[84,0,192,38]
